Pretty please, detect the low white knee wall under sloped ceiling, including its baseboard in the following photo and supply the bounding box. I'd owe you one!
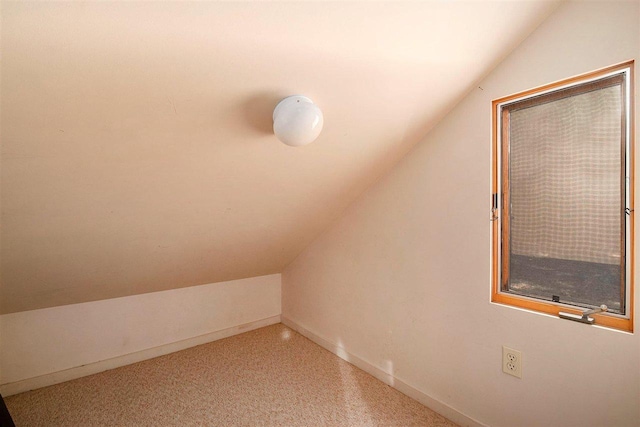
[0,274,281,395]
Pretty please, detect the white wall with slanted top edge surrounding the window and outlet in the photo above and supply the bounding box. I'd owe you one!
[282,1,640,426]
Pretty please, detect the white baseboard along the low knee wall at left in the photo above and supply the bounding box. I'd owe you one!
[0,315,281,396]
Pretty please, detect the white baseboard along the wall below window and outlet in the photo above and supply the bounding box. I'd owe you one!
[281,316,486,427]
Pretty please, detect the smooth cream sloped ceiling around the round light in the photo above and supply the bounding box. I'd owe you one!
[0,1,558,313]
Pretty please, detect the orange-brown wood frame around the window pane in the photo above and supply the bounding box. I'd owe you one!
[491,61,635,332]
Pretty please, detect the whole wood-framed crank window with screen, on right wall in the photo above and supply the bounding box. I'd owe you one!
[491,61,634,331]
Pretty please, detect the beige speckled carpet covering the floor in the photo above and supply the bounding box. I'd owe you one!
[5,324,455,427]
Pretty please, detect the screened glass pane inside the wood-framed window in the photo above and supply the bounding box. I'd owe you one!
[508,84,624,312]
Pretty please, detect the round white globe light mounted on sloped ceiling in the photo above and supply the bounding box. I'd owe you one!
[273,95,324,147]
